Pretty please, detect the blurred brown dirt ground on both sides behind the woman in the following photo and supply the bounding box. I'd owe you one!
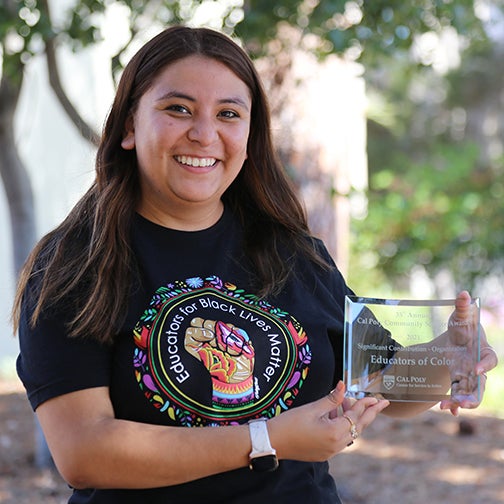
[0,381,504,504]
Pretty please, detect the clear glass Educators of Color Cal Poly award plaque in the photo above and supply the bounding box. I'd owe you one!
[345,296,480,402]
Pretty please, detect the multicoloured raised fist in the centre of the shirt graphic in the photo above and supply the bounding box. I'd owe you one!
[184,317,255,408]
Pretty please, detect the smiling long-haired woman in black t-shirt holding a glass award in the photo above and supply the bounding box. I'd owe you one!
[15,27,495,504]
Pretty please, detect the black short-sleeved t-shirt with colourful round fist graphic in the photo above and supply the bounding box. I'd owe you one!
[18,207,352,504]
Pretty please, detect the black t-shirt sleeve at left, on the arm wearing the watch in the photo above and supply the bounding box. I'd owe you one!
[17,294,110,410]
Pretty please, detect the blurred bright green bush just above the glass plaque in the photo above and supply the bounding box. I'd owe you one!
[353,142,504,290]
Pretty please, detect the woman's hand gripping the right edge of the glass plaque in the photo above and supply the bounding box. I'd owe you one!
[441,291,498,415]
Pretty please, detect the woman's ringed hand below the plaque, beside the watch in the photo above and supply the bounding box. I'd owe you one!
[268,381,389,462]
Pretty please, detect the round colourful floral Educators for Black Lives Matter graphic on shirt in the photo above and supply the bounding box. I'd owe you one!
[133,276,311,426]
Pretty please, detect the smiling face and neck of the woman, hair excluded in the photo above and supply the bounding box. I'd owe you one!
[121,55,252,230]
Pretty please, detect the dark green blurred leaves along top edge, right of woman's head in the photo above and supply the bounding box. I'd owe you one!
[240,0,486,59]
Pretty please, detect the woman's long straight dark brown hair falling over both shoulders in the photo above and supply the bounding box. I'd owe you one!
[13,26,327,342]
